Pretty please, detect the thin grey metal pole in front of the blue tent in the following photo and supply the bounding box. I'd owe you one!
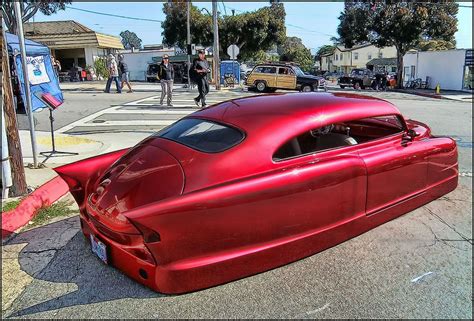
[13,1,38,168]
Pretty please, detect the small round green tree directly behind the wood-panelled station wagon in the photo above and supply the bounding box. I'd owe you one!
[277,37,314,71]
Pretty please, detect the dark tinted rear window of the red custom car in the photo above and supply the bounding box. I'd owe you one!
[155,118,244,153]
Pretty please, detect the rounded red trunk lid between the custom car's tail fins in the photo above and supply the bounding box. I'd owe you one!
[88,144,184,216]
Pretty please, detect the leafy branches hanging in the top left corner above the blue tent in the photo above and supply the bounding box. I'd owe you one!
[2,0,72,32]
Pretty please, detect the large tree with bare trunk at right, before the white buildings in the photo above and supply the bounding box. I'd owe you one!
[337,0,458,88]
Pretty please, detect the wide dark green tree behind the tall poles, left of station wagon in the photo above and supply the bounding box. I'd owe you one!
[161,2,286,60]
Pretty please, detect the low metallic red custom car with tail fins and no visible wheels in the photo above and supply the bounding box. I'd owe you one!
[56,93,458,293]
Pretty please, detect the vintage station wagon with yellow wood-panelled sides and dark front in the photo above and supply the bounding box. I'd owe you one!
[245,63,326,92]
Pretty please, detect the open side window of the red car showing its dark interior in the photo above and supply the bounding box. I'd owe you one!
[273,115,403,161]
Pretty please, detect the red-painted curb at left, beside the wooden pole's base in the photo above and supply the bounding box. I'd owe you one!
[2,176,69,239]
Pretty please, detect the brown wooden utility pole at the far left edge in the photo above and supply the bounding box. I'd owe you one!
[2,19,28,196]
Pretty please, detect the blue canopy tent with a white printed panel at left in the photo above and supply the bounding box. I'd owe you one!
[6,33,64,111]
